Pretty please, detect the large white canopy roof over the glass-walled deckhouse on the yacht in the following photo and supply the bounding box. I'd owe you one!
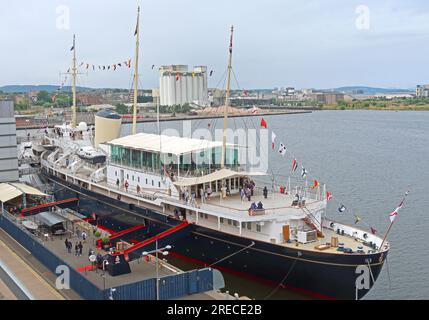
[107,133,234,156]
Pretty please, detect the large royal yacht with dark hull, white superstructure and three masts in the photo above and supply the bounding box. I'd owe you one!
[33,10,389,299]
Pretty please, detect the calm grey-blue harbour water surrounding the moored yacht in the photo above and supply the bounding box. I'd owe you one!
[20,111,429,299]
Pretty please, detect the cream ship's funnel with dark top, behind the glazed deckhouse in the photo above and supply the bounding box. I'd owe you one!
[95,109,122,148]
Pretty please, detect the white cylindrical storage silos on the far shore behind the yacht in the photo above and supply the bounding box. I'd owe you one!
[159,65,208,106]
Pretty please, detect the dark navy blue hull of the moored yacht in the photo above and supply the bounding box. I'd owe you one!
[48,175,387,299]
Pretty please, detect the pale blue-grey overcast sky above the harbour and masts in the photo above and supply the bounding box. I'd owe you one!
[0,0,429,89]
